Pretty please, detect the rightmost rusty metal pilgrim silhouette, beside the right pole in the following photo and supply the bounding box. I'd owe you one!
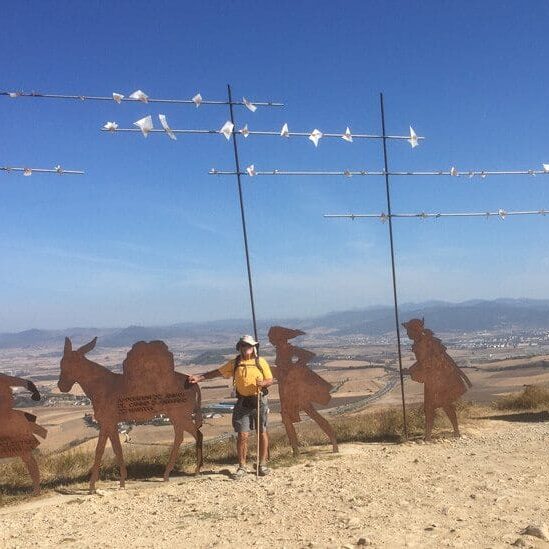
[402,318,472,441]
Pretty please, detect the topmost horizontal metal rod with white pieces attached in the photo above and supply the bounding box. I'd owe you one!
[0,90,284,107]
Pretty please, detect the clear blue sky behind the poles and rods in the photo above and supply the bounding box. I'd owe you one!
[0,0,549,331]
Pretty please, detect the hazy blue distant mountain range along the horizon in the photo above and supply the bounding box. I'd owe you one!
[0,299,549,349]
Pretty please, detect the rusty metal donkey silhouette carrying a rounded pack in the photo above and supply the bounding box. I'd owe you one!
[58,337,202,492]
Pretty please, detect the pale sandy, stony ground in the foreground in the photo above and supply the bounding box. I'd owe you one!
[0,416,549,548]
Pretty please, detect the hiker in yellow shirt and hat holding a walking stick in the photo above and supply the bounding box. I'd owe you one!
[189,335,273,479]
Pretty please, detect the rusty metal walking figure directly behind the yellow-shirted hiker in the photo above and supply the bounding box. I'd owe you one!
[269,326,338,456]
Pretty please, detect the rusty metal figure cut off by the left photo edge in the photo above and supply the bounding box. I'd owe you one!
[0,374,48,495]
